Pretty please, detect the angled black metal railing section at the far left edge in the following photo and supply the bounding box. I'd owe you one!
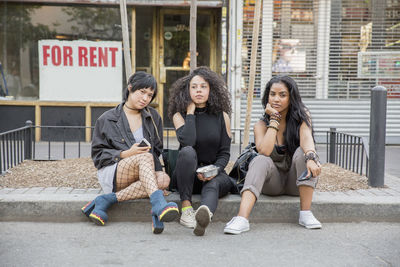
[0,121,33,174]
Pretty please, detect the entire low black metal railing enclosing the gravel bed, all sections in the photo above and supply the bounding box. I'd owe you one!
[0,121,369,177]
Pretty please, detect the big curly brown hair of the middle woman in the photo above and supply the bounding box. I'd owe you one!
[168,67,232,118]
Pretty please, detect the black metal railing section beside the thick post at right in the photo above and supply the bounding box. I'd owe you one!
[326,128,369,177]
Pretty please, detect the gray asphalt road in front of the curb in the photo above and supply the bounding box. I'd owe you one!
[0,222,400,267]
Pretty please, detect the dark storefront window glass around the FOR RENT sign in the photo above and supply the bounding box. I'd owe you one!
[0,3,123,100]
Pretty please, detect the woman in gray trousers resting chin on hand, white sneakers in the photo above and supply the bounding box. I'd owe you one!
[224,76,321,234]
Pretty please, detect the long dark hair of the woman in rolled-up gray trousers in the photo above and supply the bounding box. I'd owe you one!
[261,76,314,157]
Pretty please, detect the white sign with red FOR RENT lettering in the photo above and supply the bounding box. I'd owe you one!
[39,40,122,102]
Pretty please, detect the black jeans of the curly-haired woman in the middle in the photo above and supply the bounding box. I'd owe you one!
[174,146,235,213]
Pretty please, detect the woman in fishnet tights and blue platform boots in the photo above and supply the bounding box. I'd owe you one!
[82,72,179,234]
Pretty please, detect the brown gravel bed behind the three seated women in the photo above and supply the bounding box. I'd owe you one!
[0,158,369,192]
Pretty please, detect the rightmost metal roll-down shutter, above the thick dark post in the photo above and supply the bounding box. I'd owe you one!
[329,0,400,98]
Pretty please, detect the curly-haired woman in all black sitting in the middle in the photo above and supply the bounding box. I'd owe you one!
[168,67,235,236]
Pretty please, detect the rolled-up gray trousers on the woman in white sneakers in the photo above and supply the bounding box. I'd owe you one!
[240,147,318,198]
